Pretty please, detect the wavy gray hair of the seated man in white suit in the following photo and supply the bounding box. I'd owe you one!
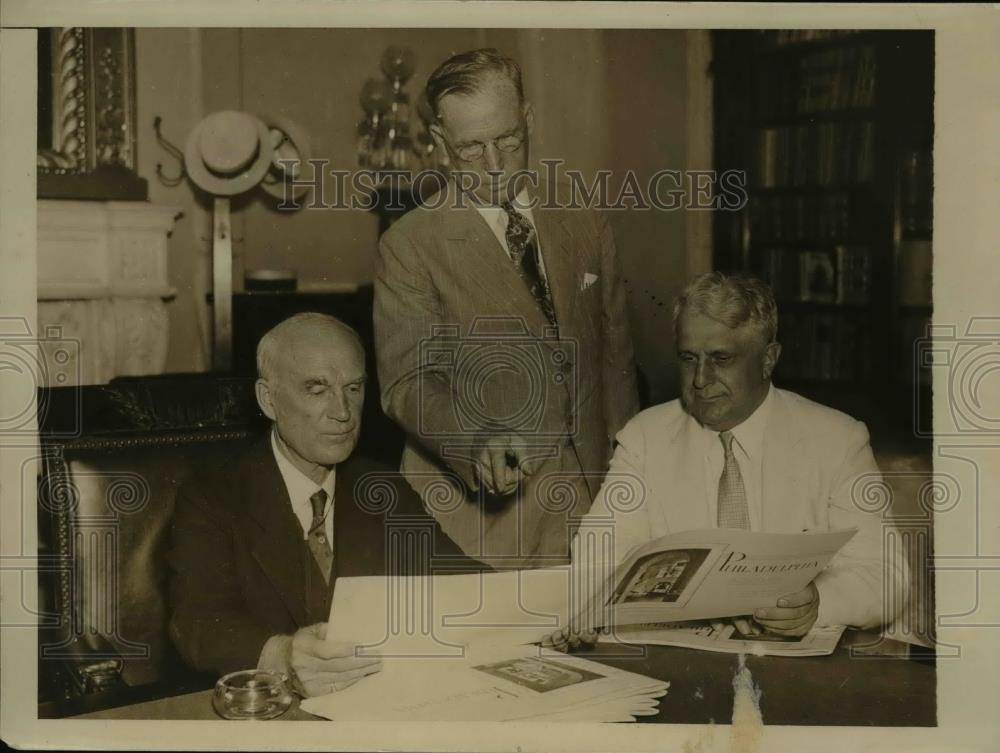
[674,272,778,344]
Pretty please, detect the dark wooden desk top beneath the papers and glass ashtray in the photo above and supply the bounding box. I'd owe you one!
[75,631,937,727]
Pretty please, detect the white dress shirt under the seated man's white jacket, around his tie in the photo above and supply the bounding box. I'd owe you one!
[701,385,774,531]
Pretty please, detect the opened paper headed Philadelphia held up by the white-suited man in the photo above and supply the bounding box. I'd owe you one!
[572,529,856,630]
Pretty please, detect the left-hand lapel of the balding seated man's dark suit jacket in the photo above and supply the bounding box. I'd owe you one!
[242,434,310,625]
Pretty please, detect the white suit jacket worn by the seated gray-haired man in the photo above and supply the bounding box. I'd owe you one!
[573,388,907,627]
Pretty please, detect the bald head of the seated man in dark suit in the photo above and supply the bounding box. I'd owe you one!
[257,313,366,483]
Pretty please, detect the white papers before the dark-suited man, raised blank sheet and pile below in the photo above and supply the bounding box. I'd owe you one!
[302,568,668,722]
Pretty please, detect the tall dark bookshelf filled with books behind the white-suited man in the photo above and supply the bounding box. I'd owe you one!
[712,30,934,426]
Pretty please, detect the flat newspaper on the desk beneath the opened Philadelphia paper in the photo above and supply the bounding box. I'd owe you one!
[599,620,845,656]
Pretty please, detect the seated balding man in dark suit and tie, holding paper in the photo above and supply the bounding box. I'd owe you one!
[169,313,480,695]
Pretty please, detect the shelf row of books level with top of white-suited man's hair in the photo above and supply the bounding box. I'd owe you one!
[760,246,872,305]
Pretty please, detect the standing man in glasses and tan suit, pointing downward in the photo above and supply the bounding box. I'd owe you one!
[375,50,638,567]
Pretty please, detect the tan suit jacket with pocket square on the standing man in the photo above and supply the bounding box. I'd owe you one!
[374,179,638,565]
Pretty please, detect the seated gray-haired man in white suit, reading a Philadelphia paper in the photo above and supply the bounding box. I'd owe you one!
[546,272,907,649]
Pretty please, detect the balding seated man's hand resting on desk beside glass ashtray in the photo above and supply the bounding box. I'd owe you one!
[288,622,382,697]
